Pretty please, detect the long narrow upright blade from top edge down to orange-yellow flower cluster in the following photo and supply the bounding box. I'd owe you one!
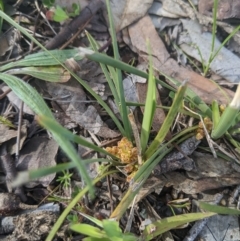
[106,0,132,140]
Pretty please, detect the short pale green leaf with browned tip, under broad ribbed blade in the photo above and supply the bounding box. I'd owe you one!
[5,66,71,83]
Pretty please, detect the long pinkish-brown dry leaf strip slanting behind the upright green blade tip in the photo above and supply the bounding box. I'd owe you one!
[128,16,233,104]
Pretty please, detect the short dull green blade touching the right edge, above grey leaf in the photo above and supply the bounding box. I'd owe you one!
[199,202,240,215]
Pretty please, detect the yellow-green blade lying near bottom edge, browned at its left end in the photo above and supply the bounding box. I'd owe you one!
[142,212,216,241]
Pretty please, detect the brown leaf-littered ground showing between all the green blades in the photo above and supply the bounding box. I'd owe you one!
[0,0,240,241]
